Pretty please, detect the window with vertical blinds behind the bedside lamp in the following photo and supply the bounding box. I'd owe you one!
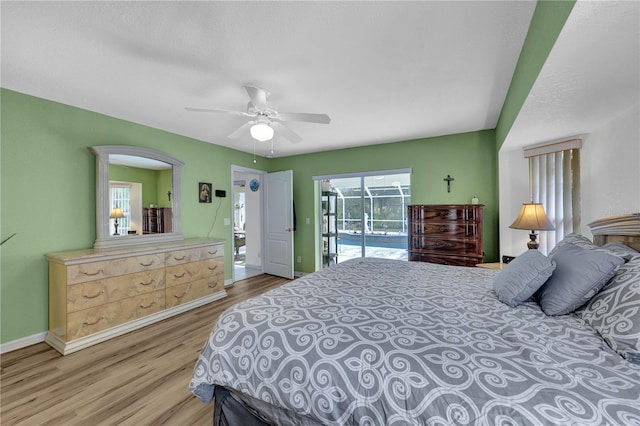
[524,139,582,254]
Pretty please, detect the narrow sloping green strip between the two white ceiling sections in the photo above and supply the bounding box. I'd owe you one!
[496,0,576,150]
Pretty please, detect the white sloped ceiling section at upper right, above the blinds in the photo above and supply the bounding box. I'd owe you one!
[503,1,640,149]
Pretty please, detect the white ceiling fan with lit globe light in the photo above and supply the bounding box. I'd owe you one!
[186,84,331,143]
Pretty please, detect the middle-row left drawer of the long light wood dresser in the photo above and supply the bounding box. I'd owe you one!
[67,269,164,312]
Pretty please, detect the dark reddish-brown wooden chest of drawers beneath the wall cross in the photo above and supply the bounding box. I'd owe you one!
[408,204,484,266]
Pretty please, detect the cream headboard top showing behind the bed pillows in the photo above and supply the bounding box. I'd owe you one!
[588,213,640,251]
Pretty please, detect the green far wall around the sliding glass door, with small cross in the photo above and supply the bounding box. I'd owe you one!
[271,130,498,272]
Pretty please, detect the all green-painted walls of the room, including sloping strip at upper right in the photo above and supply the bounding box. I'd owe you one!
[0,0,575,343]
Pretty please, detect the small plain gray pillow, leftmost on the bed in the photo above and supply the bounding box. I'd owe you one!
[493,250,556,307]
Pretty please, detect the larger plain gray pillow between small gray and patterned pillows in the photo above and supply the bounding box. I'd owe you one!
[537,243,624,315]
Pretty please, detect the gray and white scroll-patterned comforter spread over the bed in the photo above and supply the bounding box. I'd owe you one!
[190,258,640,425]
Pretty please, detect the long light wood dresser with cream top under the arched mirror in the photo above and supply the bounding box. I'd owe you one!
[45,239,227,355]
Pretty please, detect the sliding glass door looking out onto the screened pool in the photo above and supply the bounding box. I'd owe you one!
[316,169,411,266]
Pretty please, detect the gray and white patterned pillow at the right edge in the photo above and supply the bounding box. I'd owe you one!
[582,256,640,363]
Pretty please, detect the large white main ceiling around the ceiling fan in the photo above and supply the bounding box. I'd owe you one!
[1,1,535,157]
